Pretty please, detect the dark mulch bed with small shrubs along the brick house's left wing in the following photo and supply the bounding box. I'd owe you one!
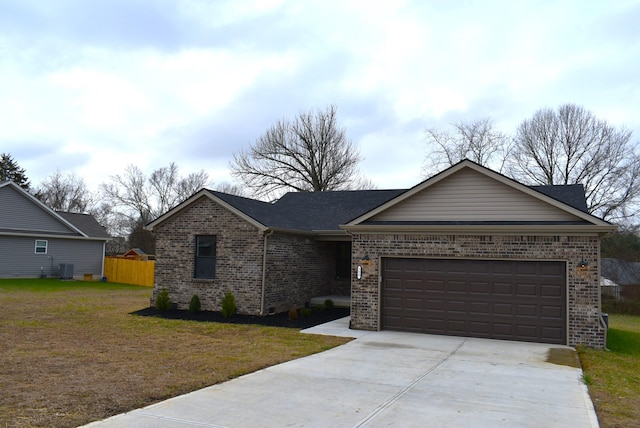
[132,307,349,330]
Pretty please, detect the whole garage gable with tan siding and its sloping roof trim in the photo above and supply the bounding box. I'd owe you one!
[346,160,610,226]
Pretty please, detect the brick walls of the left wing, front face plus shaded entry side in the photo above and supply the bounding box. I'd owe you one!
[151,198,350,315]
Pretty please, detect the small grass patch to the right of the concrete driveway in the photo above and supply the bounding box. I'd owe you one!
[578,314,640,428]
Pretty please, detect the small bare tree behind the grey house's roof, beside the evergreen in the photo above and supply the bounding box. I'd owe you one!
[35,170,96,213]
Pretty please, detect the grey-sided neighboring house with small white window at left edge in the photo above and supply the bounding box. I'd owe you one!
[0,181,110,278]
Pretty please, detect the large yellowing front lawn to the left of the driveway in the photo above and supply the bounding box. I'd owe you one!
[0,279,349,427]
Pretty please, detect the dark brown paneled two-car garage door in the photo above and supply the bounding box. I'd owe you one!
[382,258,566,344]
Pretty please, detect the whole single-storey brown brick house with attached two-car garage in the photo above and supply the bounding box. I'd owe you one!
[148,160,615,348]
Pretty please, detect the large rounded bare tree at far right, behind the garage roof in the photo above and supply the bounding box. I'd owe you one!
[509,104,640,221]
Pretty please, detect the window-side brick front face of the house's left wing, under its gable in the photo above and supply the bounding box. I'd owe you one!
[151,197,264,314]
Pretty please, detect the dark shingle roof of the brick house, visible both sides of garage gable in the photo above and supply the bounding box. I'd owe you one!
[209,184,587,232]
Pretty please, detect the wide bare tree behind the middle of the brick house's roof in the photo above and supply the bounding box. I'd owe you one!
[231,106,370,197]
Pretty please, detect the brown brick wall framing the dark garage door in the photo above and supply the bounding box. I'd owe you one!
[351,234,604,348]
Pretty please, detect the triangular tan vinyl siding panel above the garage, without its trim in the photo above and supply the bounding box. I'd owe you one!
[369,168,581,221]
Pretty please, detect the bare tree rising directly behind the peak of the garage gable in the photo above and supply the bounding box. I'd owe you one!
[425,118,511,175]
